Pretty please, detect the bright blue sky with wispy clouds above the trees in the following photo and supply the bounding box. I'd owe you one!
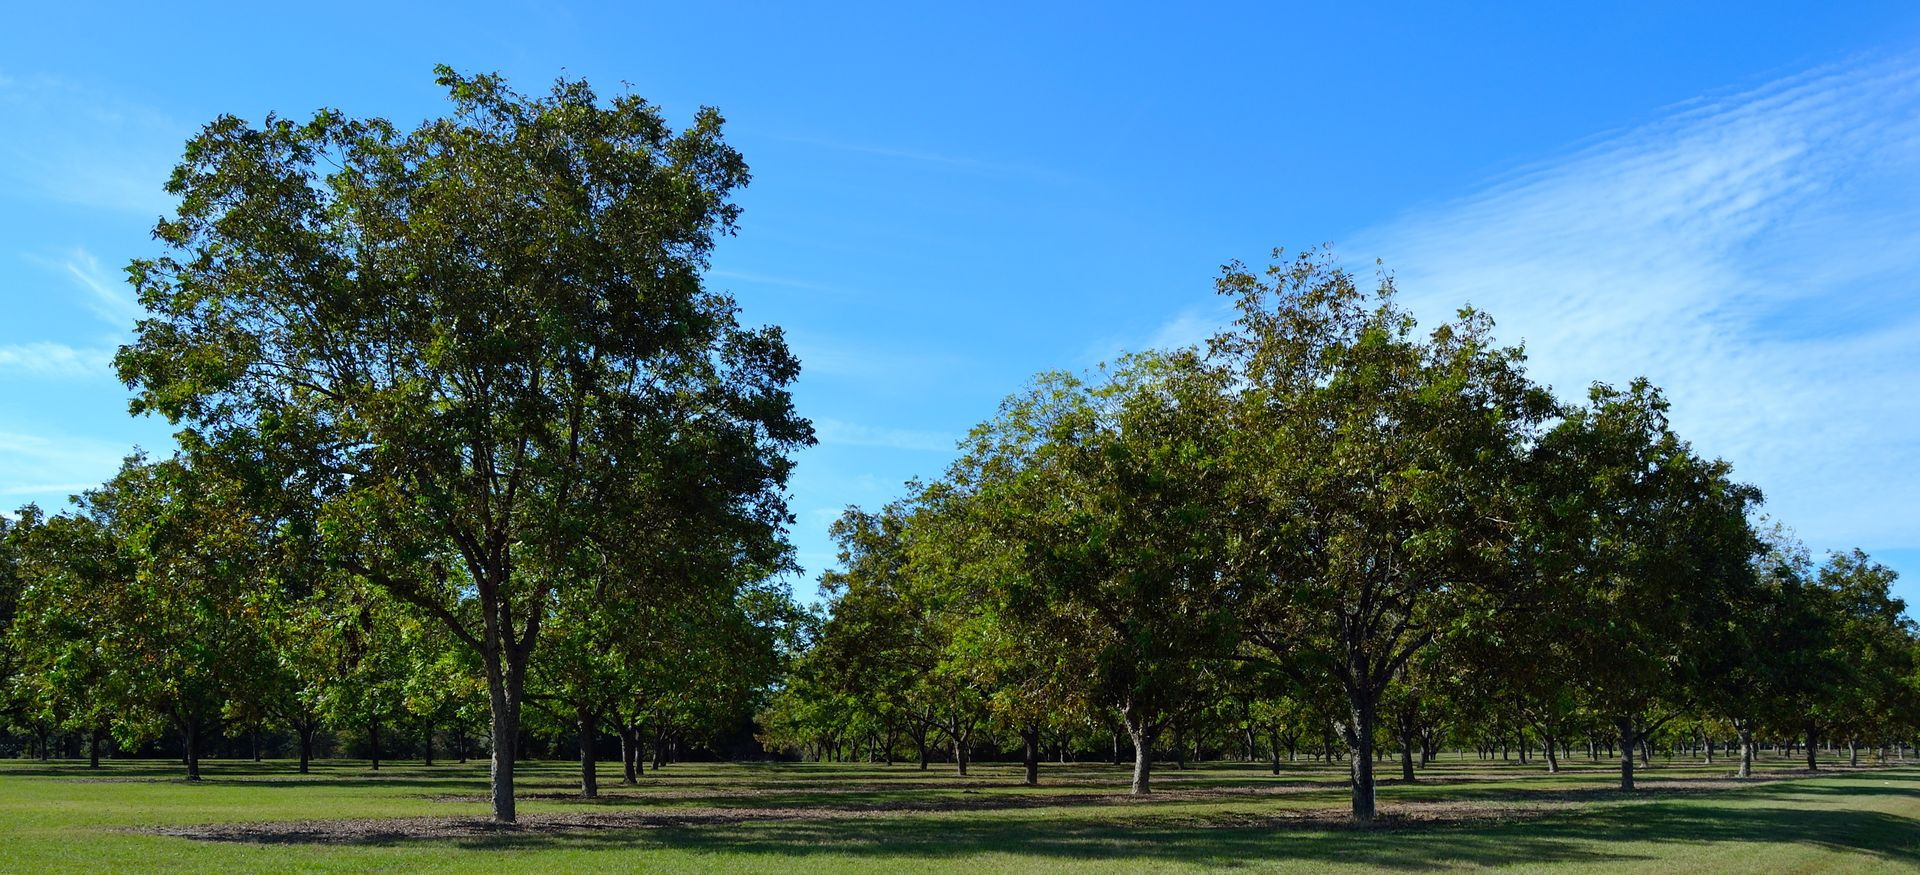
[0,2,1920,601]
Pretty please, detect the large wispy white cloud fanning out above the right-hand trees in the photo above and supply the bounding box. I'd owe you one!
[1342,56,1920,547]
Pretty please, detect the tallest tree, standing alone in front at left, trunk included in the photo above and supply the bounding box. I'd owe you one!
[117,67,812,821]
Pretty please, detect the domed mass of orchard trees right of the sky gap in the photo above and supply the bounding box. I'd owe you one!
[764,253,1920,819]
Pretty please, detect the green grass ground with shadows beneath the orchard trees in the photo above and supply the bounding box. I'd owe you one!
[0,756,1920,875]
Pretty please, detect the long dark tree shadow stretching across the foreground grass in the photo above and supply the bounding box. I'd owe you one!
[161,785,1920,871]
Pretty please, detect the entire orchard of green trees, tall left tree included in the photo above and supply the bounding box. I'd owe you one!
[0,69,1916,821]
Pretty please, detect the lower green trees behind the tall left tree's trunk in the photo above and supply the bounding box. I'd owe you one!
[0,455,799,782]
